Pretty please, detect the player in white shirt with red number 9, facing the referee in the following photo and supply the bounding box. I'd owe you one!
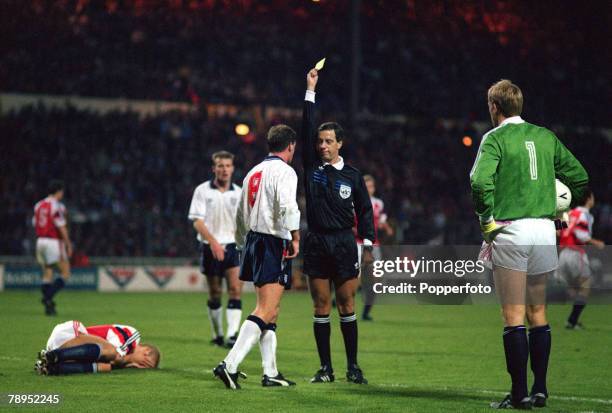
[213,125,300,389]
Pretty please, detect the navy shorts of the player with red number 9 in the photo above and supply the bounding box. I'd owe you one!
[240,231,291,290]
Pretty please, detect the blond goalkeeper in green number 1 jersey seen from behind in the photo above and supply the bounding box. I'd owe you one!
[470,80,588,409]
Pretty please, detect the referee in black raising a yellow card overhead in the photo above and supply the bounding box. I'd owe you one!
[302,69,374,384]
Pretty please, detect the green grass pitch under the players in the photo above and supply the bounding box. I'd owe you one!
[0,292,612,412]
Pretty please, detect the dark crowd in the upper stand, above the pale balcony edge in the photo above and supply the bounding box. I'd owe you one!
[0,0,610,125]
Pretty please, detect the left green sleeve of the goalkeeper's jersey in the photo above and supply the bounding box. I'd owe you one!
[470,135,501,221]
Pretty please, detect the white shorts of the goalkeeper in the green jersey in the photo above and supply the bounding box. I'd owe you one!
[491,218,559,275]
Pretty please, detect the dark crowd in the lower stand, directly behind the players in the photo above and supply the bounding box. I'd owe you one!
[0,106,612,257]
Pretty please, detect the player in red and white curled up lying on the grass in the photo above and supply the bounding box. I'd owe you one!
[34,320,160,376]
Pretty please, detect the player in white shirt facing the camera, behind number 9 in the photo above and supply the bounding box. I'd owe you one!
[189,151,242,347]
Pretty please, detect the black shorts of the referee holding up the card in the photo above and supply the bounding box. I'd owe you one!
[304,229,359,279]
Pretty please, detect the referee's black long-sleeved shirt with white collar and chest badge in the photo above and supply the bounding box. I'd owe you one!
[301,94,375,241]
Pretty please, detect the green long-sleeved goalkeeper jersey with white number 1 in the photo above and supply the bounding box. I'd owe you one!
[470,116,589,221]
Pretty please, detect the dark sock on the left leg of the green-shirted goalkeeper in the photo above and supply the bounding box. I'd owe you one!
[503,325,529,403]
